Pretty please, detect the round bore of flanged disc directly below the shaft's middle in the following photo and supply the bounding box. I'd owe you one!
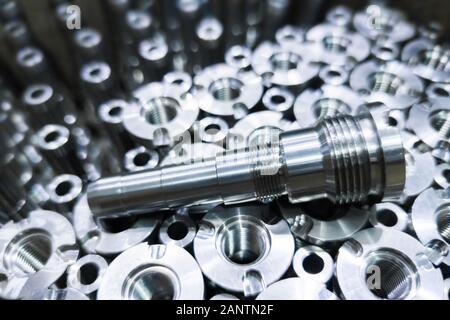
[220,218,268,265]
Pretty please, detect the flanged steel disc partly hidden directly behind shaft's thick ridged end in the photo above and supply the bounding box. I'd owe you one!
[294,85,364,128]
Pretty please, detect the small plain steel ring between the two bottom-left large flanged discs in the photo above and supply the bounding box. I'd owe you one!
[67,254,108,295]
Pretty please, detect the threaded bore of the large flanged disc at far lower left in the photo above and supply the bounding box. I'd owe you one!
[3,229,52,274]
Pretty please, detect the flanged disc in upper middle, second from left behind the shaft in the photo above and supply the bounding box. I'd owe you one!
[194,64,263,120]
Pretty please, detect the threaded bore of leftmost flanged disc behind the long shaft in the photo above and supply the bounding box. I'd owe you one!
[145,97,180,125]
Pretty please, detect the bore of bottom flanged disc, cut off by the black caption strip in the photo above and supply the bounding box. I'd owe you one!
[125,266,177,300]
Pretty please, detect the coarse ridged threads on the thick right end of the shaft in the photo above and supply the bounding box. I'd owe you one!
[322,115,371,204]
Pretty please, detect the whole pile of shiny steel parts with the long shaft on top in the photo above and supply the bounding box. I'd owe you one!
[0,0,450,300]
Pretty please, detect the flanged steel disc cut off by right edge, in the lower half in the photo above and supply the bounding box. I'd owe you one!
[412,189,450,265]
